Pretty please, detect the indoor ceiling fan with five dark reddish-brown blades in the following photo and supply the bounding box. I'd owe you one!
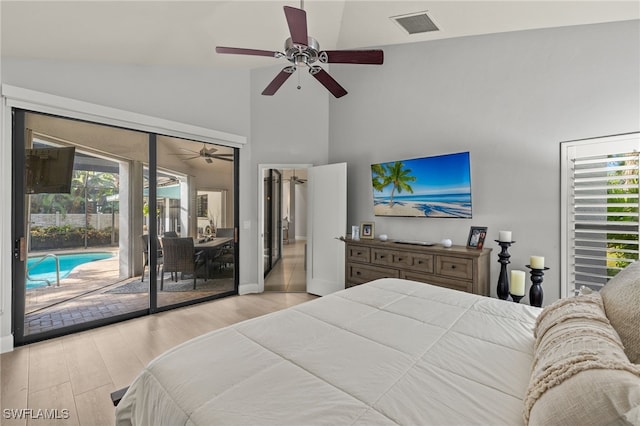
[216,1,384,98]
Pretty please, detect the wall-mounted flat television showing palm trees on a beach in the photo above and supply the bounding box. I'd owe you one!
[371,152,472,219]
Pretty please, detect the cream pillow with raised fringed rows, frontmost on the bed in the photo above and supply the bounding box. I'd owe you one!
[524,293,640,426]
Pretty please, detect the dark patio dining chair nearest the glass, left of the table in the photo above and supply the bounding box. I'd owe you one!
[160,237,209,290]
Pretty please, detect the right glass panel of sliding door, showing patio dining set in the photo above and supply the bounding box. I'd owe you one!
[156,136,236,308]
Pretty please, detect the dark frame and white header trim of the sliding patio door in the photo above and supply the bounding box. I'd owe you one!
[0,85,246,352]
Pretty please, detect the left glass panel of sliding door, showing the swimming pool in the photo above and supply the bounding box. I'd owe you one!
[14,111,149,344]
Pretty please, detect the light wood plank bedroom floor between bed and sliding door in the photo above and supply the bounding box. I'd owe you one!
[0,293,315,426]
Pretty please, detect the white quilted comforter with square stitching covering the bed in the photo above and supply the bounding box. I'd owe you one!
[117,279,540,426]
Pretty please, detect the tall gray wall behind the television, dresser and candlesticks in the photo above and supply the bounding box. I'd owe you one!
[329,21,640,304]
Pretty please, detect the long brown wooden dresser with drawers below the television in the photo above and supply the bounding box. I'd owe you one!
[344,238,491,296]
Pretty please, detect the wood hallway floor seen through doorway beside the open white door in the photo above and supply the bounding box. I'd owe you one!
[264,240,307,293]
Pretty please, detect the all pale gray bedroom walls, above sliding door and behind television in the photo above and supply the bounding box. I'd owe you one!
[0,21,640,350]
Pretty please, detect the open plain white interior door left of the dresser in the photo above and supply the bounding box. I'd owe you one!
[307,163,347,296]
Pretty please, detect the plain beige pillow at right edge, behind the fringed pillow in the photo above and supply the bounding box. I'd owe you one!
[600,261,640,364]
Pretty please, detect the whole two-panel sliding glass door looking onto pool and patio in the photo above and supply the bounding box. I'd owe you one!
[13,110,237,344]
